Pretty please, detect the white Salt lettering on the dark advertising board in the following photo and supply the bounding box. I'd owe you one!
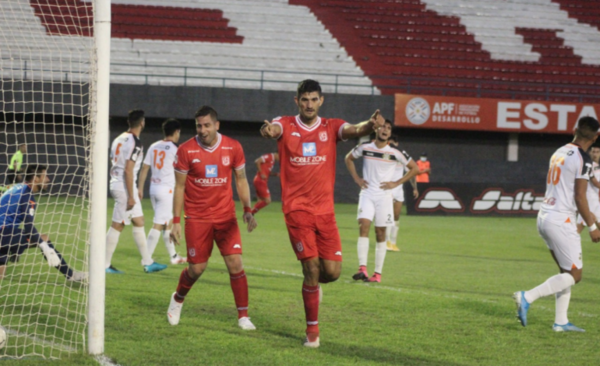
[471,188,544,213]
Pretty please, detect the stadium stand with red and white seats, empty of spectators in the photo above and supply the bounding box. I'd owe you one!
[0,0,600,101]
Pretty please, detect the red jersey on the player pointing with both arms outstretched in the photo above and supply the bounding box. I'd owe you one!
[273,116,347,215]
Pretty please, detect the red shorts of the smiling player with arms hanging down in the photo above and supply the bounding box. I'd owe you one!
[185,219,242,264]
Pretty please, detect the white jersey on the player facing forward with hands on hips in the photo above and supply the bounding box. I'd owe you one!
[352,142,411,195]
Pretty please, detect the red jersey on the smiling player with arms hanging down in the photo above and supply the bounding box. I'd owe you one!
[175,133,246,222]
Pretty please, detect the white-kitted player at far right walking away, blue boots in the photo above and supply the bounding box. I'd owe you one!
[513,117,600,332]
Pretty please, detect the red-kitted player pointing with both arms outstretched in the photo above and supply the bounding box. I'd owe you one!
[261,80,385,348]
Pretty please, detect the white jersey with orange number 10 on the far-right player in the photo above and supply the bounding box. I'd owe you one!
[539,143,592,222]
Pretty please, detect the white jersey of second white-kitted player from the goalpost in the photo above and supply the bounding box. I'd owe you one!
[144,140,177,188]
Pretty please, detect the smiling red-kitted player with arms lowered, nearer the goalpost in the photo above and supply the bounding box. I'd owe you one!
[167,106,256,330]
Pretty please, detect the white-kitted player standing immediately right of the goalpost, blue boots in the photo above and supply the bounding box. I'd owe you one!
[105,109,167,274]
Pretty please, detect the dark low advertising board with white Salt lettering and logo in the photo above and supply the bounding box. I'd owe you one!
[404,183,546,217]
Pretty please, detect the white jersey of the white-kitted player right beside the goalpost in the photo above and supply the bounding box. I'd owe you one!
[110,132,144,191]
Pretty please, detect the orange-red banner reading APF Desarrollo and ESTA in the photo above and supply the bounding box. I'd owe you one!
[394,94,600,134]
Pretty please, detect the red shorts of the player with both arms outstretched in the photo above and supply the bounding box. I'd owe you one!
[285,211,342,262]
